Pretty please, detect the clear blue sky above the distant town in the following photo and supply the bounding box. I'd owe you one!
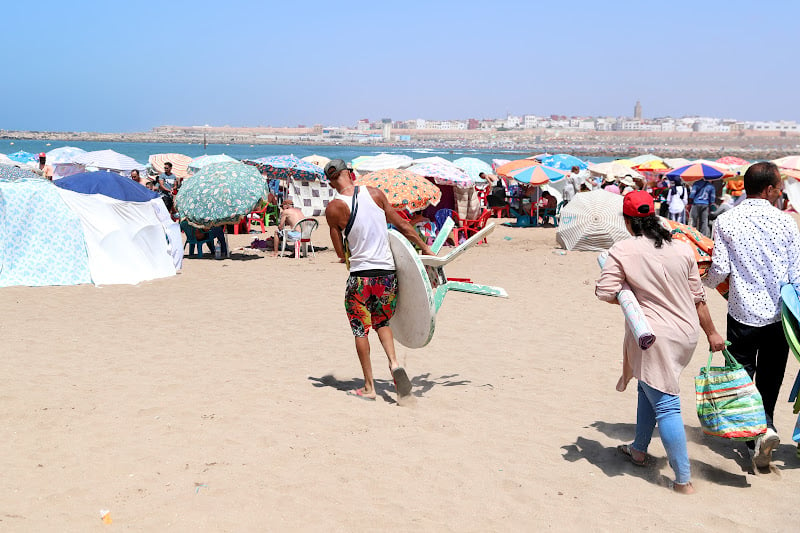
[0,0,800,132]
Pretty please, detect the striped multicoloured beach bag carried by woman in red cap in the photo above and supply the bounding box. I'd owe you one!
[694,349,767,440]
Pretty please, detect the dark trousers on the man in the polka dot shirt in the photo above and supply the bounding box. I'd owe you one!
[728,315,789,429]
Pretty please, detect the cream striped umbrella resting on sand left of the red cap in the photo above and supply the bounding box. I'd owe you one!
[556,189,630,252]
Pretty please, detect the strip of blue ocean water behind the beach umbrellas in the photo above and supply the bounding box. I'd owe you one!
[0,139,612,164]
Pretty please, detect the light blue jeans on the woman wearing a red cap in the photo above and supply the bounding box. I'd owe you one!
[631,381,691,483]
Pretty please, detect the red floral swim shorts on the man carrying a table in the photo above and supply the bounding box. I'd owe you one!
[344,274,397,337]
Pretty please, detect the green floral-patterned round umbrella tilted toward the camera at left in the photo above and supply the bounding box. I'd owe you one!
[175,162,267,228]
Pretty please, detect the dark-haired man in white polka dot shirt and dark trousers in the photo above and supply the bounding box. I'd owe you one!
[704,162,800,468]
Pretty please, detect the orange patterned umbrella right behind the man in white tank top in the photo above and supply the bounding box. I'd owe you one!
[355,168,442,211]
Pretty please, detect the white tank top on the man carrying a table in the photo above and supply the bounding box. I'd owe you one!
[334,187,394,272]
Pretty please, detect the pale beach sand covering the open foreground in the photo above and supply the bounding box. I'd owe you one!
[0,218,800,532]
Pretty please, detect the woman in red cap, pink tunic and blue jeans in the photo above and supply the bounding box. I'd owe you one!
[595,191,725,494]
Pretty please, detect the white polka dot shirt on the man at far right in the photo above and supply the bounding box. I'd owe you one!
[703,198,800,327]
